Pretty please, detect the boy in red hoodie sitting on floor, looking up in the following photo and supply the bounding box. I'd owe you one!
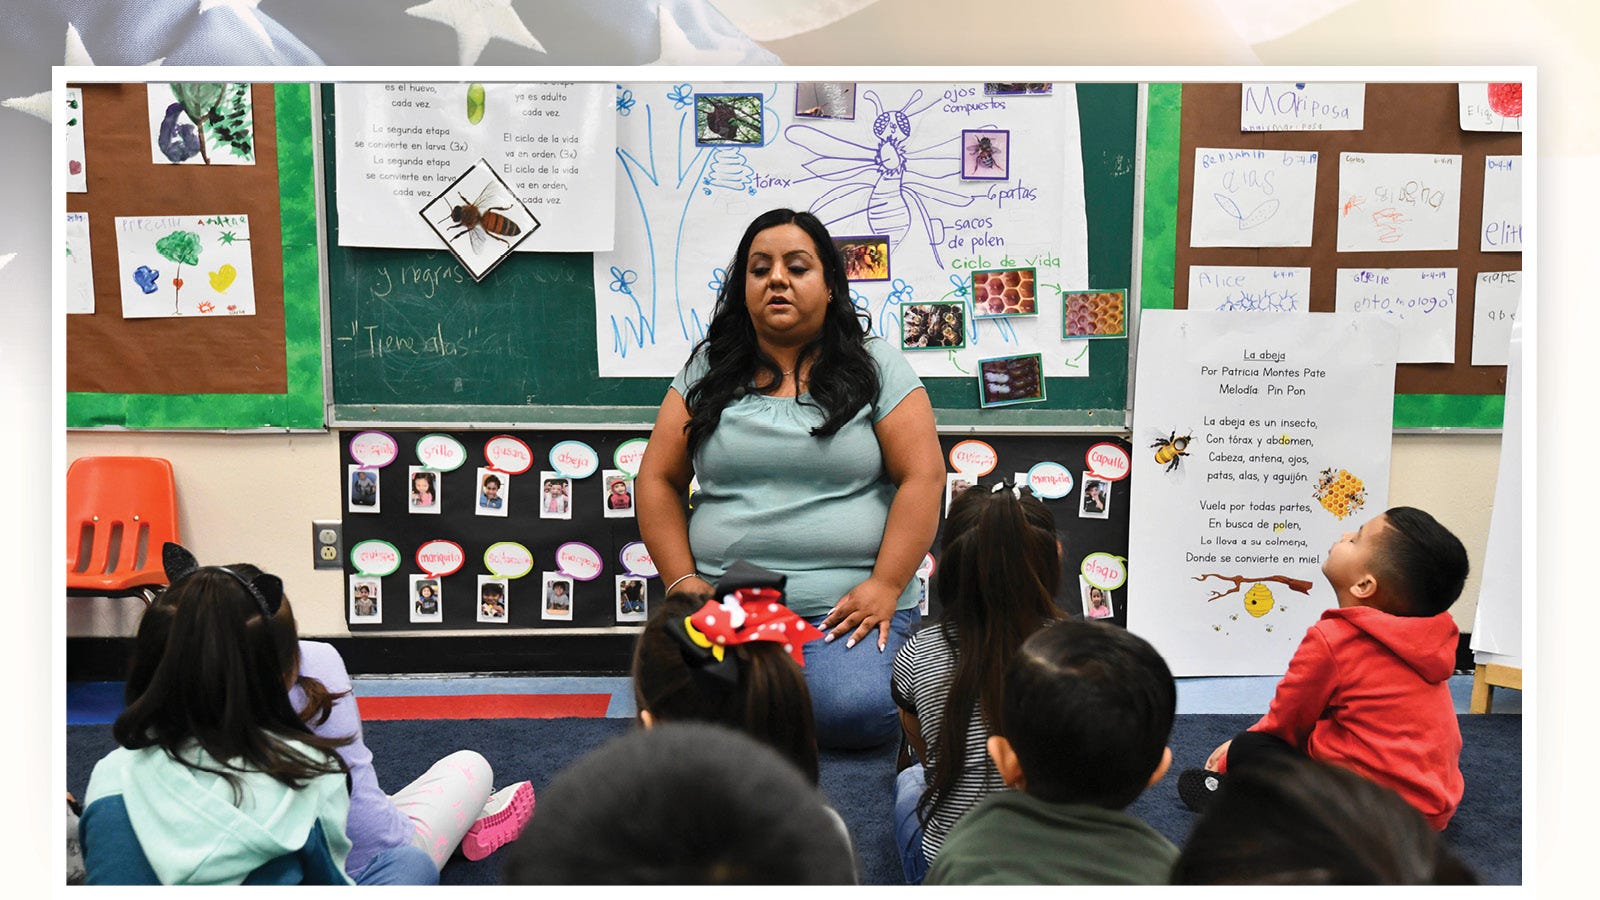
[1178,506,1467,830]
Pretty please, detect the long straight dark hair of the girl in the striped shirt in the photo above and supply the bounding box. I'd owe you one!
[917,487,1062,823]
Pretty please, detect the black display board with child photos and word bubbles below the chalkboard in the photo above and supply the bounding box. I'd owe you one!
[338,429,1131,634]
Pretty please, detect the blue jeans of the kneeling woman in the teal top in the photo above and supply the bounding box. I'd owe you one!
[805,607,920,749]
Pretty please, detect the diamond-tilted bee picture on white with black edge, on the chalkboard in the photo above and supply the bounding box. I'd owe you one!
[421,159,539,282]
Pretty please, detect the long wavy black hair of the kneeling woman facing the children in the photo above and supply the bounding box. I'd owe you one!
[683,210,878,456]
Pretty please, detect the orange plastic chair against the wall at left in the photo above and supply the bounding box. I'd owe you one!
[67,456,178,605]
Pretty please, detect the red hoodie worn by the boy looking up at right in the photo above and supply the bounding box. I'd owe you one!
[1250,607,1462,830]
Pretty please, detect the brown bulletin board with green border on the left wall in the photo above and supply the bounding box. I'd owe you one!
[66,83,323,429]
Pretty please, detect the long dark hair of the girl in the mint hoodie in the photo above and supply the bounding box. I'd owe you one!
[112,567,350,801]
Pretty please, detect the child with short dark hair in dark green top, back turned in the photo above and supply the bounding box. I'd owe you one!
[925,620,1178,884]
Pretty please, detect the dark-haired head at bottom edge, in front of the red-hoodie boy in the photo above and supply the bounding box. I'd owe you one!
[1173,754,1477,884]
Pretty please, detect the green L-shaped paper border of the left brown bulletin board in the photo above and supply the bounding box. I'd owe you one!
[67,83,323,429]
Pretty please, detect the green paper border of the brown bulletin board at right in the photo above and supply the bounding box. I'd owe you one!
[1139,83,1506,429]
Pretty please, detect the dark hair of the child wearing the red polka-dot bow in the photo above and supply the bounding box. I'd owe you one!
[634,591,818,785]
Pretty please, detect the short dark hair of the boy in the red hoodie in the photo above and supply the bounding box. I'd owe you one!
[1371,506,1467,615]
